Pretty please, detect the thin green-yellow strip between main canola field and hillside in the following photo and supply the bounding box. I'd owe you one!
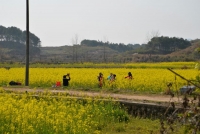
[0,62,196,69]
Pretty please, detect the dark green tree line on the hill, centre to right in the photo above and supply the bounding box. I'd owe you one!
[81,36,191,54]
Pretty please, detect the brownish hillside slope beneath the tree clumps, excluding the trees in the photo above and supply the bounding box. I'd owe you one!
[0,40,200,63]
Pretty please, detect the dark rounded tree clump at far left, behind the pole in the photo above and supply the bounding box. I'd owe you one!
[0,25,41,47]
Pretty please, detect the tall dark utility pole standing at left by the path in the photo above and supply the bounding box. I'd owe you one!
[25,0,29,86]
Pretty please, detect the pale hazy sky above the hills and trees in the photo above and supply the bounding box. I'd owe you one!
[0,0,200,47]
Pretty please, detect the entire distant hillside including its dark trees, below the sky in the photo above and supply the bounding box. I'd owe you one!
[0,26,200,63]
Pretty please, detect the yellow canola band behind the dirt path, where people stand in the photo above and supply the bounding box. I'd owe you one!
[0,68,198,93]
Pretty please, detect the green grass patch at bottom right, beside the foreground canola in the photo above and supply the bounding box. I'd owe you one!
[102,117,186,134]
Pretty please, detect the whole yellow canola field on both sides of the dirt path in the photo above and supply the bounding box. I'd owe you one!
[0,63,195,134]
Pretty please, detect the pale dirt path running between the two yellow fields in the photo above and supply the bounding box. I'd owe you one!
[3,87,182,102]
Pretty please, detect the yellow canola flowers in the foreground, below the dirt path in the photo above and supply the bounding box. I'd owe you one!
[0,92,128,134]
